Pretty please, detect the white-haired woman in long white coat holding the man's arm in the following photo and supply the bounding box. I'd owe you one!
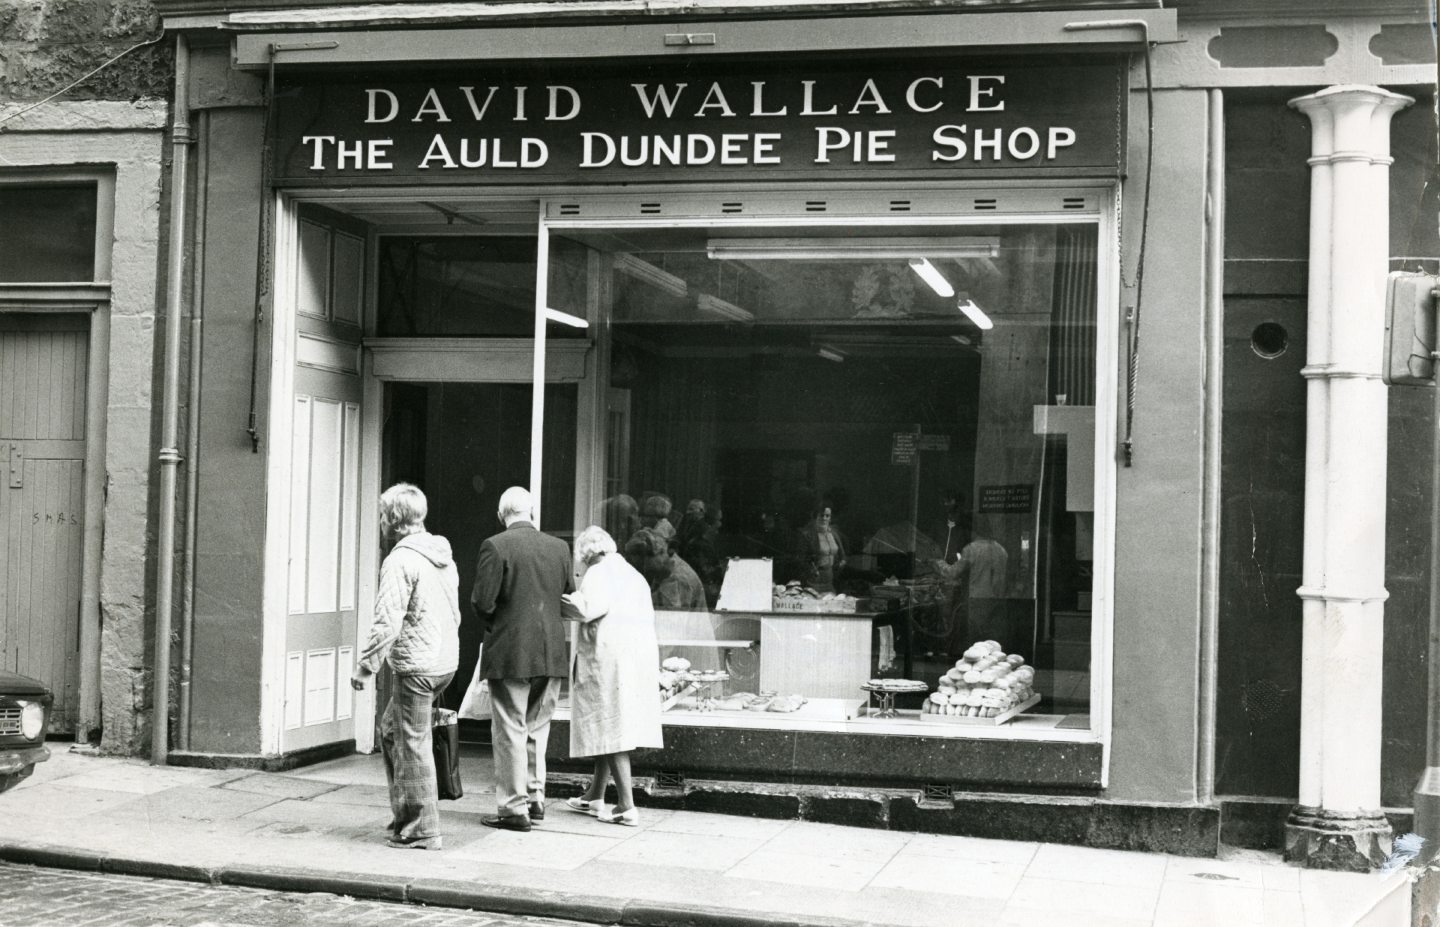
[563,525,664,828]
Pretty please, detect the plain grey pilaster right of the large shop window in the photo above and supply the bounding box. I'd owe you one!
[1107,91,1207,802]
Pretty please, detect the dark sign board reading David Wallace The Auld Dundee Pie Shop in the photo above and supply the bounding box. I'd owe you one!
[272,56,1125,186]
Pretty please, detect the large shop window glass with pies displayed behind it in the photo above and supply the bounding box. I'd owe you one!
[549,222,1097,734]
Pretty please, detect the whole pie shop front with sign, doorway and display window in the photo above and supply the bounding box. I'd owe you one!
[171,1,1238,846]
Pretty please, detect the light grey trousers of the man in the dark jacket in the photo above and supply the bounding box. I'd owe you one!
[490,677,562,818]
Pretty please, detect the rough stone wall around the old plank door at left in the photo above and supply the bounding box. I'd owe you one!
[0,0,174,754]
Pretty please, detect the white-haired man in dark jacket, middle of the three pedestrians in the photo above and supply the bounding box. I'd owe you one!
[469,487,575,831]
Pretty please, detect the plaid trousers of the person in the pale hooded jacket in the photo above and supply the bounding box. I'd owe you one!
[380,672,455,844]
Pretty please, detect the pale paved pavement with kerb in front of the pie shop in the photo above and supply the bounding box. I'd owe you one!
[0,747,1408,927]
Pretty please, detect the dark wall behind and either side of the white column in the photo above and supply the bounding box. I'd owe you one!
[1215,89,1440,806]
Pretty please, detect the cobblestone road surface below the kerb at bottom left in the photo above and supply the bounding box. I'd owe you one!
[0,862,590,927]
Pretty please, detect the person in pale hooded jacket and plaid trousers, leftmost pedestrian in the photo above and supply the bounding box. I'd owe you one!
[350,482,459,849]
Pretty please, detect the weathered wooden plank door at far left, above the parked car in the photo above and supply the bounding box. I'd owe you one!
[0,314,89,731]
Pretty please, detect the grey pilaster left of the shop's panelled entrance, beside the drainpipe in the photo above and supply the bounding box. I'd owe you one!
[190,65,269,753]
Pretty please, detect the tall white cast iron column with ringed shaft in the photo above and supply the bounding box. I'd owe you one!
[1284,86,1414,871]
